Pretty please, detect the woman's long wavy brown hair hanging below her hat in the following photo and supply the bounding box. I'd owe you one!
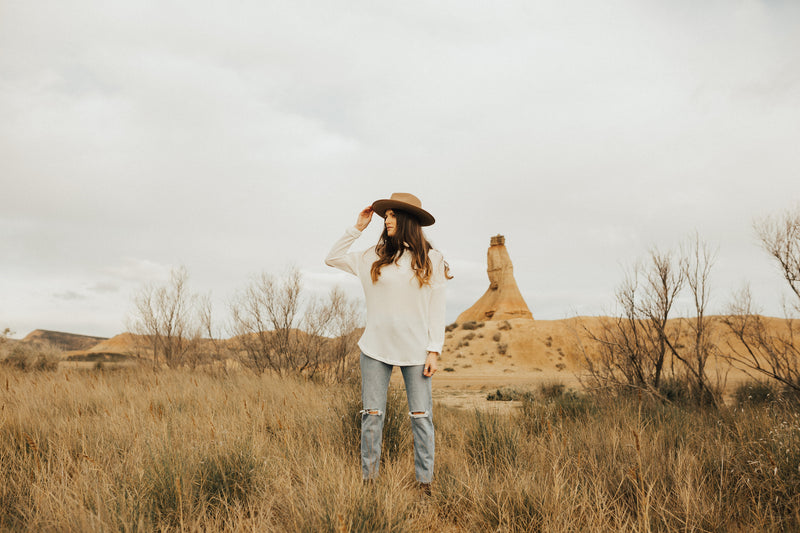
[370,210,453,287]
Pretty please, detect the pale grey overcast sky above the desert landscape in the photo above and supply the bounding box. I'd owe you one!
[0,0,800,337]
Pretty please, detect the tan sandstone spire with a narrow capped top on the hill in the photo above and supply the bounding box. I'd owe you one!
[457,235,533,324]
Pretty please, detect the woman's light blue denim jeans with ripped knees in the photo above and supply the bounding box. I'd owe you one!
[361,353,434,483]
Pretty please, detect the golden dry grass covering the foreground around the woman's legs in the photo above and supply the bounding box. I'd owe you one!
[0,367,800,531]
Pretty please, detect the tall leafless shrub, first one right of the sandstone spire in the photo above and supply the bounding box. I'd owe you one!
[582,236,719,404]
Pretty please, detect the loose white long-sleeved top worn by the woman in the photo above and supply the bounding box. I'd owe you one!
[325,227,447,366]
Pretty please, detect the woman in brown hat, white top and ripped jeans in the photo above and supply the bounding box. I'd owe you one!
[325,193,452,493]
